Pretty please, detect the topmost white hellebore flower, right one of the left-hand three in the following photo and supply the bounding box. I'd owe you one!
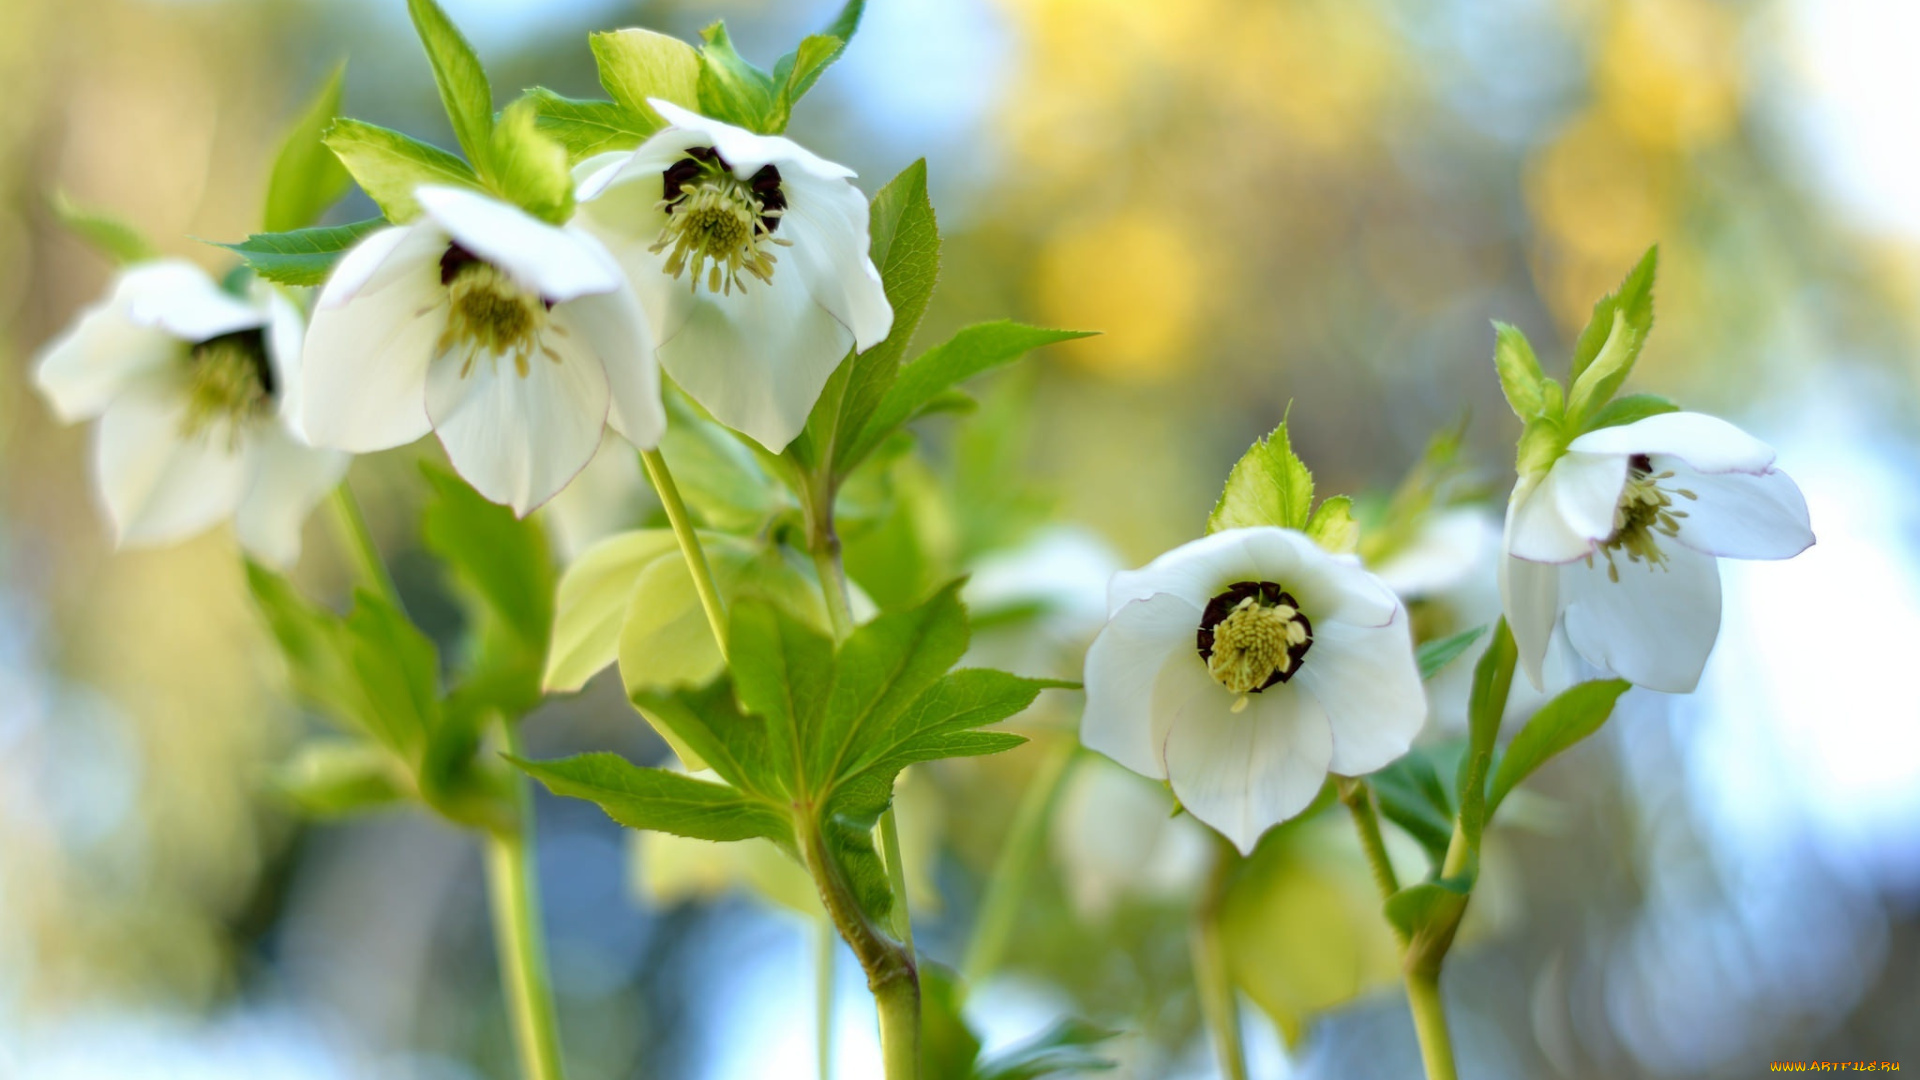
[574,100,893,454]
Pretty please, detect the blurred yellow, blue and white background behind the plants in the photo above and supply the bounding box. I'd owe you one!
[0,0,1920,1080]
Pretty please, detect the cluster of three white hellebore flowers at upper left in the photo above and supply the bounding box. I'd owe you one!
[36,100,893,565]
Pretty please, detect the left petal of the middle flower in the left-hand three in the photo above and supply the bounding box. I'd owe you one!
[296,225,447,454]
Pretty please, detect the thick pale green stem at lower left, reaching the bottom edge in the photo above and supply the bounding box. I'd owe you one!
[486,721,566,1080]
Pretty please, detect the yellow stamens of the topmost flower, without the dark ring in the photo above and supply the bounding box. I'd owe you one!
[647,169,793,294]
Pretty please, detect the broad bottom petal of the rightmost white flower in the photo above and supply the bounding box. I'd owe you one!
[1561,544,1720,694]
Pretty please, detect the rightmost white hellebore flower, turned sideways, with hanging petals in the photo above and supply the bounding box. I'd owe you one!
[1500,413,1812,694]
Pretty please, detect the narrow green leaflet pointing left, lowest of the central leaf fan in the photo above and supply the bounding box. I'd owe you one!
[511,753,793,849]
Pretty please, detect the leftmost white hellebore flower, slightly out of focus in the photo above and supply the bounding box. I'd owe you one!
[35,259,348,567]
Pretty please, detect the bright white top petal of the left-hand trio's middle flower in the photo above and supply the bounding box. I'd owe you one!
[413,184,620,304]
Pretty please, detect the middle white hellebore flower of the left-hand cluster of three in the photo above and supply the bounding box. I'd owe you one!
[301,186,666,515]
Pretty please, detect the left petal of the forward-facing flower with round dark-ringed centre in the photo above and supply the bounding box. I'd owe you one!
[1081,594,1212,780]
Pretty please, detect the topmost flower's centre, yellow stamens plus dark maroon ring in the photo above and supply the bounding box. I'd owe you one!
[647,146,793,294]
